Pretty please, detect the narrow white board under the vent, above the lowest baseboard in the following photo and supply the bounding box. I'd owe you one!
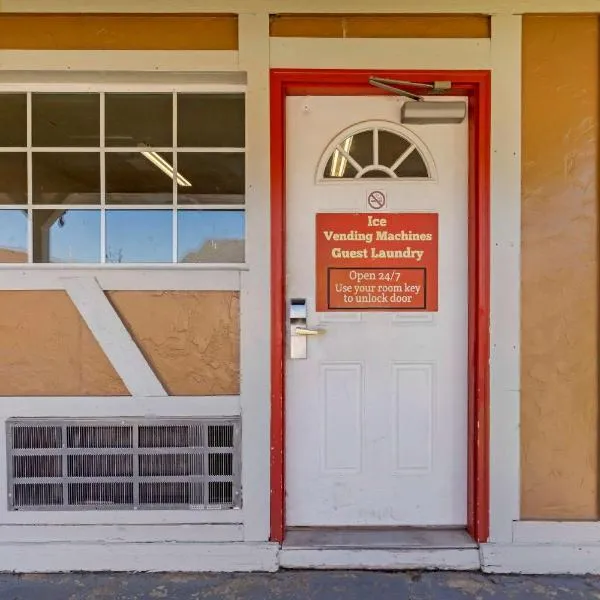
[0,523,244,544]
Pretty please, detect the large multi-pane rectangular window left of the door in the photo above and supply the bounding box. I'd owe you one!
[0,92,245,264]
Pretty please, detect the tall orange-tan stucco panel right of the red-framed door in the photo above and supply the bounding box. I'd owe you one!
[521,16,599,519]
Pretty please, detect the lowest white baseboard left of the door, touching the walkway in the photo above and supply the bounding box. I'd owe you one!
[0,542,277,573]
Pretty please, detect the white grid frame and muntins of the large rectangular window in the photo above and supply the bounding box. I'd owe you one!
[0,82,248,271]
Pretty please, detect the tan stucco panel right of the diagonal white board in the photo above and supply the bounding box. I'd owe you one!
[108,291,240,396]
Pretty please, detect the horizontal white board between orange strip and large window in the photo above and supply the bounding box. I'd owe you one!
[0,50,238,73]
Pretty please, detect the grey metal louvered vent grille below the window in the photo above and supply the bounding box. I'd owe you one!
[7,419,242,510]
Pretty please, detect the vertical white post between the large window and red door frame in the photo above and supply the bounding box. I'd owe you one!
[239,14,271,541]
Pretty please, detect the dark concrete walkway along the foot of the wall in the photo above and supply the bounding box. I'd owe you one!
[0,571,600,600]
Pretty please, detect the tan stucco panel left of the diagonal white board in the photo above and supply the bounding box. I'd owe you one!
[0,291,128,396]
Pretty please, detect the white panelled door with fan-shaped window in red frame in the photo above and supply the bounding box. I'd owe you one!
[286,96,468,526]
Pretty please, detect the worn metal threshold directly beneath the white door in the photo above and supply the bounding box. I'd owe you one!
[283,527,477,550]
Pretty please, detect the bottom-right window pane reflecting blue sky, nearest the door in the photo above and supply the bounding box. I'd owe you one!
[177,210,245,263]
